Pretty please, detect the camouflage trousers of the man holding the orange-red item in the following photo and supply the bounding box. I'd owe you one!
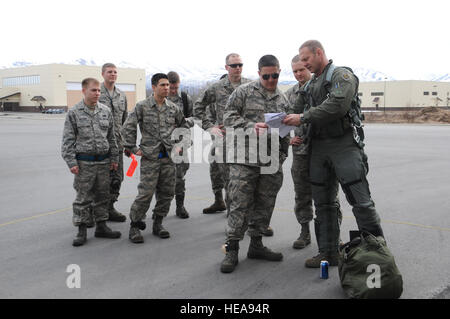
[130,157,175,222]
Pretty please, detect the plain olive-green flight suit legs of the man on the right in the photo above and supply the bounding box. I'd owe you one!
[310,133,382,253]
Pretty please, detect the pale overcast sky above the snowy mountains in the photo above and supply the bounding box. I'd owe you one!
[0,0,450,80]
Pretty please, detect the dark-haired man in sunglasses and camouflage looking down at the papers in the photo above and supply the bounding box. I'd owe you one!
[221,55,289,273]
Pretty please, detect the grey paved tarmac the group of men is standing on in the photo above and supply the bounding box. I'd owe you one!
[0,113,450,299]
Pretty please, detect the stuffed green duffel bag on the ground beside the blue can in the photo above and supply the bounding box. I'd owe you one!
[338,233,403,299]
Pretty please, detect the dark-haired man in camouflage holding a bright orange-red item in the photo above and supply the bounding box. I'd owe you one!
[122,73,190,243]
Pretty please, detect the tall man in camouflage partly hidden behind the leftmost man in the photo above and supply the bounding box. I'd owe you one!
[99,63,128,222]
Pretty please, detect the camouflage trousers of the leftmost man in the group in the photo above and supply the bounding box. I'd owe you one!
[72,161,110,227]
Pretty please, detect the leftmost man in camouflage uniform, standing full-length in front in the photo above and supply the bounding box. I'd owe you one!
[61,78,120,246]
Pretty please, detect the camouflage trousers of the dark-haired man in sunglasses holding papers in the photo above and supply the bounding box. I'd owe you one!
[227,164,283,242]
